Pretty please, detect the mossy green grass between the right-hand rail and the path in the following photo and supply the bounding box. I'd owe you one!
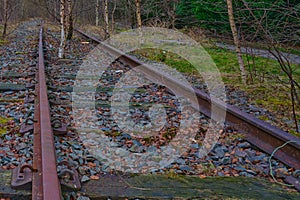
[133,44,300,133]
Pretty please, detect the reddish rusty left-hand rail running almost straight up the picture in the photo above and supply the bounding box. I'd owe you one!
[32,28,62,200]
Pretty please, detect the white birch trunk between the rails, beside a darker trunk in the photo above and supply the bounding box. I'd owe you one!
[58,0,66,58]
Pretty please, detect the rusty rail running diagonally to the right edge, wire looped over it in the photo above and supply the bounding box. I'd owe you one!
[76,29,300,189]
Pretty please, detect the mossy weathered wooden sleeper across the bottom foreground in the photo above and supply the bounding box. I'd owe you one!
[0,171,300,200]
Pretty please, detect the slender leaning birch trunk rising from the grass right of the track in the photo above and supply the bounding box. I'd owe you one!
[226,0,247,84]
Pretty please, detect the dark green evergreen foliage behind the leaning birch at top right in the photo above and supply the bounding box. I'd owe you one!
[177,0,300,44]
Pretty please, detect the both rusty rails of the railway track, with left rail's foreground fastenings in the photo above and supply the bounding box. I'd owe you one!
[0,22,300,200]
